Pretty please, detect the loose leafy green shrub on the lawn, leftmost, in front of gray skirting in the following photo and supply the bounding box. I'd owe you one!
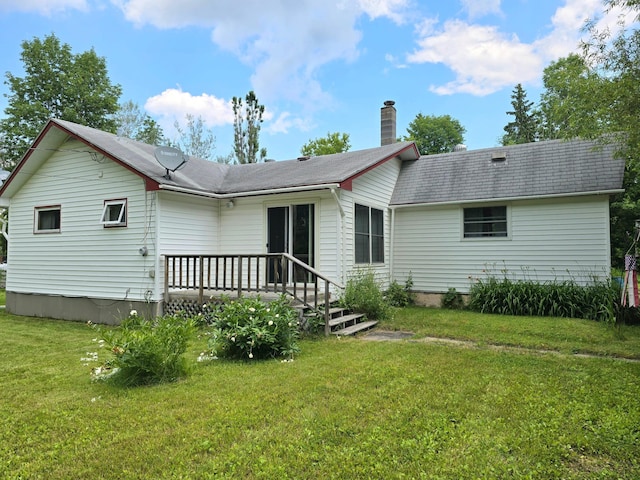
[94,310,195,386]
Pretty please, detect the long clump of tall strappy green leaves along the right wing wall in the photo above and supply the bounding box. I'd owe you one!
[468,276,620,322]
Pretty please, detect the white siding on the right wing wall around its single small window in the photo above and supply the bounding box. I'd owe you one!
[393,197,610,293]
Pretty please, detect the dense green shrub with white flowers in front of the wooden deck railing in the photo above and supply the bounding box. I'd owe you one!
[209,296,299,359]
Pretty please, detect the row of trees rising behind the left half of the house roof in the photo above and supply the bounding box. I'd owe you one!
[0,34,266,170]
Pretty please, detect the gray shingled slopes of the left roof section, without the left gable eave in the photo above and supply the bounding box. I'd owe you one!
[53,120,417,194]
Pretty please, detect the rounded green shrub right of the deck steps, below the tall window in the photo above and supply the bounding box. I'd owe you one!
[340,270,391,320]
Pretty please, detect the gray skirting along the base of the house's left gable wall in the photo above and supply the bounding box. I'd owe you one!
[5,292,158,325]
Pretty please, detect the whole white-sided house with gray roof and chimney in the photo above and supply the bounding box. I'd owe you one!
[0,104,624,323]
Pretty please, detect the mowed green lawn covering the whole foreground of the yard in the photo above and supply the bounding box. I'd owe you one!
[0,309,640,479]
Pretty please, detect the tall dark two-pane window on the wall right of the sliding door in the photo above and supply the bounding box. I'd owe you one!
[354,203,384,263]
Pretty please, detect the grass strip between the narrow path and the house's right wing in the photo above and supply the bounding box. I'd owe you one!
[381,307,640,359]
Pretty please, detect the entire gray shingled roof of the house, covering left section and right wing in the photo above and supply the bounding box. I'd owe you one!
[0,120,624,205]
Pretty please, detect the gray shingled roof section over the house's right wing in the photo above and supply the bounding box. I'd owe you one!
[391,140,624,205]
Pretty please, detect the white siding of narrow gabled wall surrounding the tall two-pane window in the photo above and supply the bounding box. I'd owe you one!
[341,159,401,286]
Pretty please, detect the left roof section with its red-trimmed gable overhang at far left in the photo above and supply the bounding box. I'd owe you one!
[0,119,419,198]
